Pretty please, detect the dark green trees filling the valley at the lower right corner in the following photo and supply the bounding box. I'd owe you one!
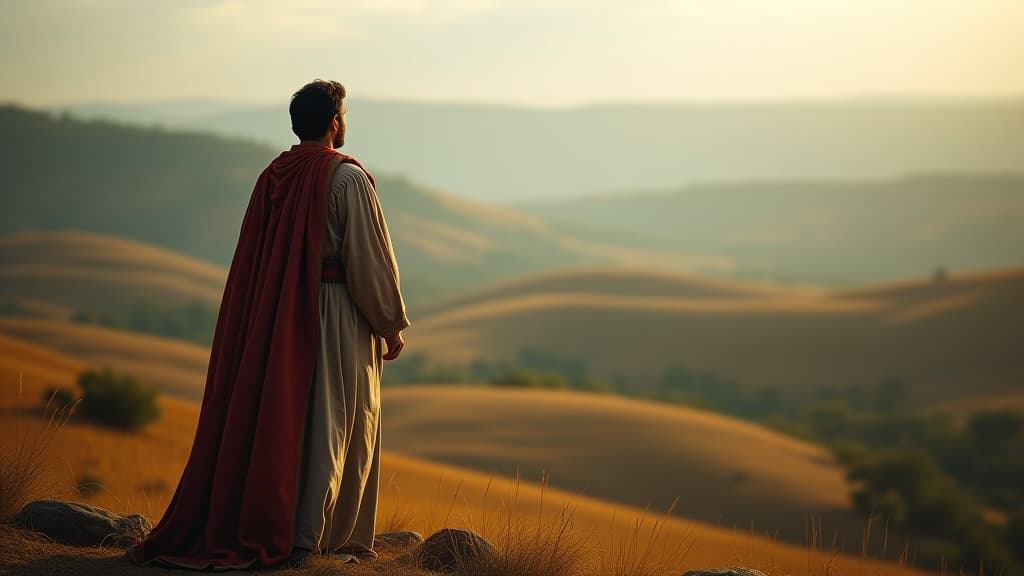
[788,380,1024,574]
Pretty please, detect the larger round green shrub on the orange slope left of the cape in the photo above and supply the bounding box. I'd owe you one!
[78,369,160,430]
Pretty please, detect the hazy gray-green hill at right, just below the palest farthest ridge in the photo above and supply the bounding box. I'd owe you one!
[518,172,1024,285]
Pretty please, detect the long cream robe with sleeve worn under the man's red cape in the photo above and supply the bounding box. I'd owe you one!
[295,163,410,556]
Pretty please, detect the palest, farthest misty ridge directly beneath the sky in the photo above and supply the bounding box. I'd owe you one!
[65,97,1024,203]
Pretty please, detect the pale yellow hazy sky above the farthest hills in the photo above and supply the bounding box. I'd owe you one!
[0,0,1024,106]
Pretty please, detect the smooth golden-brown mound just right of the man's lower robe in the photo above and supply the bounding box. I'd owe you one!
[383,386,861,549]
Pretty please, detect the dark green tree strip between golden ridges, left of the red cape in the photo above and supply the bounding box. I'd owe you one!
[72,300,219,345]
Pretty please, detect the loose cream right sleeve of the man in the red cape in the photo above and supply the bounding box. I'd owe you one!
[333,163,410,338]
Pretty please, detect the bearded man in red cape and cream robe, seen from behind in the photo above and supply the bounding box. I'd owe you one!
[127,80,410,570]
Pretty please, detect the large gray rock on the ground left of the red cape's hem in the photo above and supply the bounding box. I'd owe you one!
[14,500,153,548]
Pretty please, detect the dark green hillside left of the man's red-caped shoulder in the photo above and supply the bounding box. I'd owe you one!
[0,107,274,264]
